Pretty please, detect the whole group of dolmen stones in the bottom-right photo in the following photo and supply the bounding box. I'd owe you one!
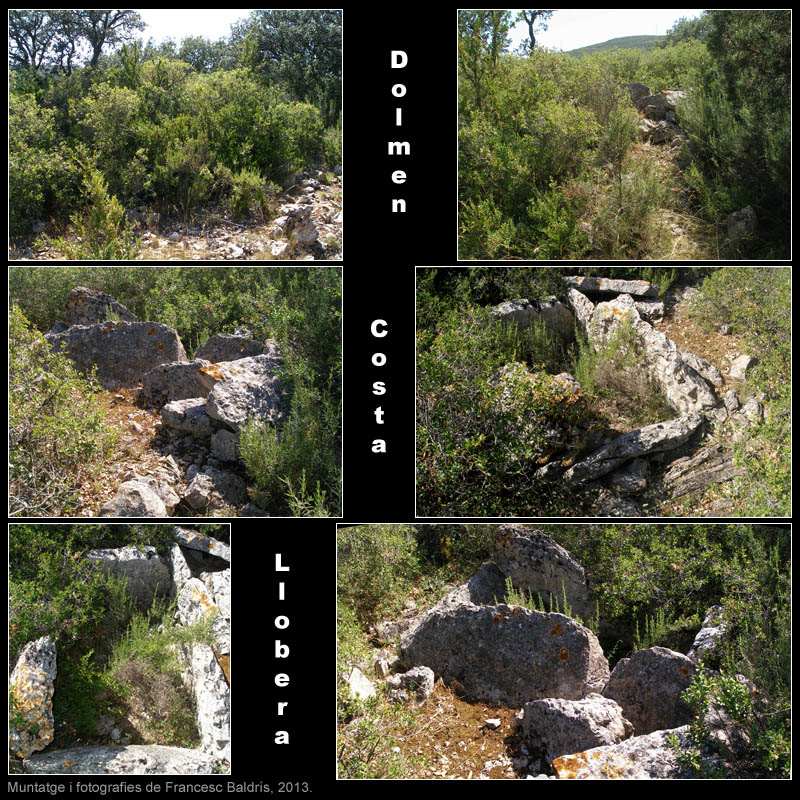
[343,525,752,779]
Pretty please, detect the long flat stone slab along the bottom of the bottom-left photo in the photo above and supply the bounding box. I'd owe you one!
[24,744,223,775]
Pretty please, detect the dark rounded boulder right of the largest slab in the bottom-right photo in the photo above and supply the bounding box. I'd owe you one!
[603,647,695,736]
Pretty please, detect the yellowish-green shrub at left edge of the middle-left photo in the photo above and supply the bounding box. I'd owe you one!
[9,306,115,516]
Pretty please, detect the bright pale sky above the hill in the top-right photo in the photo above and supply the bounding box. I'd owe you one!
[511,8,702,50]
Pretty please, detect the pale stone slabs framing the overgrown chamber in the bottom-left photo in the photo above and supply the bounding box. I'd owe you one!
[9,527,231,775]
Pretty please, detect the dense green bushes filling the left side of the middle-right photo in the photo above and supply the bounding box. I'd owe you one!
[417,308,591,516]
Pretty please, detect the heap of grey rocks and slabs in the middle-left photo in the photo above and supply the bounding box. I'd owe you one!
[45,287,288,517]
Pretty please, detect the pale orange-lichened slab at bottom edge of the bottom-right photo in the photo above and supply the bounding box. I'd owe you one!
[551,726,690,780]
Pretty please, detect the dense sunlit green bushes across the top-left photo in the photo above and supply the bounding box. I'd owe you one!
[9,12,341,242]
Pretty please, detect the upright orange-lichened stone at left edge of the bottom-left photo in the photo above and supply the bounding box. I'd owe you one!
[8,636,56,758]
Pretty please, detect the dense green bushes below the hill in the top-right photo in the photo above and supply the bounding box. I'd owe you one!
[459,11,791,259]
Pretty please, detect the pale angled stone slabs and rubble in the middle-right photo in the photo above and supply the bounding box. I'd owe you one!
[494,276,764,516]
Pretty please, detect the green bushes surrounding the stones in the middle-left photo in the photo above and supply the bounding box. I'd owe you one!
[9,267,341,514]
